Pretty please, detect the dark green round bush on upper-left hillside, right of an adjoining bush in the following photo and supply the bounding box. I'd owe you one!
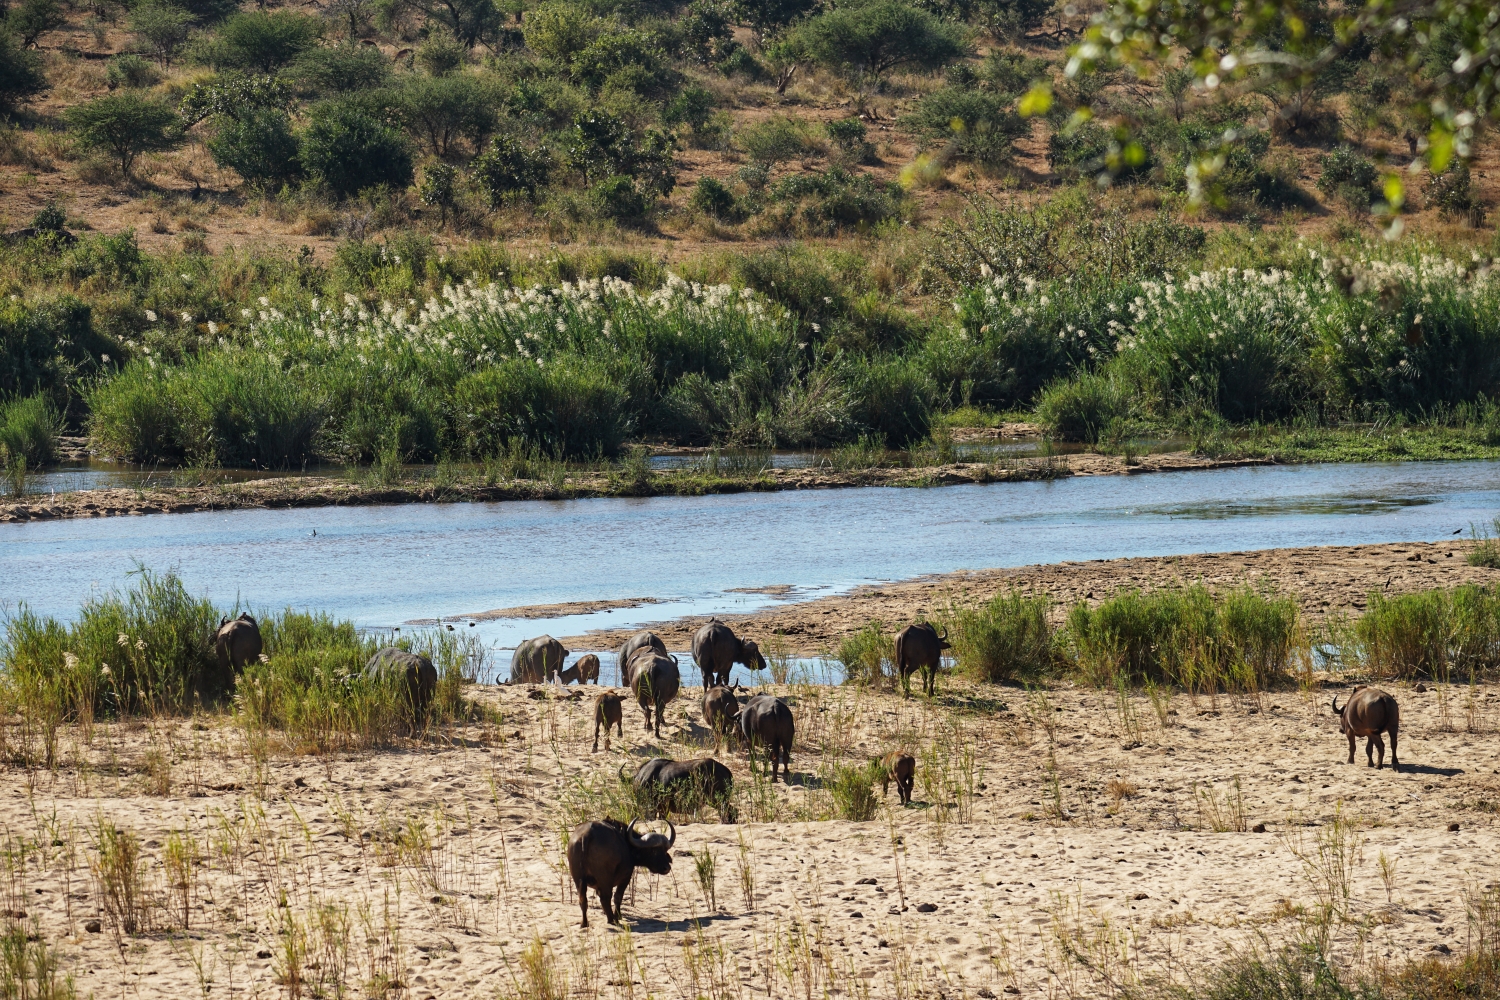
[302,102,413,196]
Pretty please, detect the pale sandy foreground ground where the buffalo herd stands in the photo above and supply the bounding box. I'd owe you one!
[0,665,1500,1000]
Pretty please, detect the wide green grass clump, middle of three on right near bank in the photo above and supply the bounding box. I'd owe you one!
[1067,585,1307,691]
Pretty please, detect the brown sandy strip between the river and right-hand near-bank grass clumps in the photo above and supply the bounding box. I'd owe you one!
[579,540,1500,657]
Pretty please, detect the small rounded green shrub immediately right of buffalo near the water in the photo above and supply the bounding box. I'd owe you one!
[951,591,1053,684]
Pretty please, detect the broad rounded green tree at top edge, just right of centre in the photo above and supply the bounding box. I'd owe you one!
[798,0,966,79]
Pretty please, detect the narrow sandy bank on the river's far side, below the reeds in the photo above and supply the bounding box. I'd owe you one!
[0,451,1274,523]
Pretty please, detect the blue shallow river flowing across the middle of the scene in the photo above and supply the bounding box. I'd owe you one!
[0,462,1500,689]
